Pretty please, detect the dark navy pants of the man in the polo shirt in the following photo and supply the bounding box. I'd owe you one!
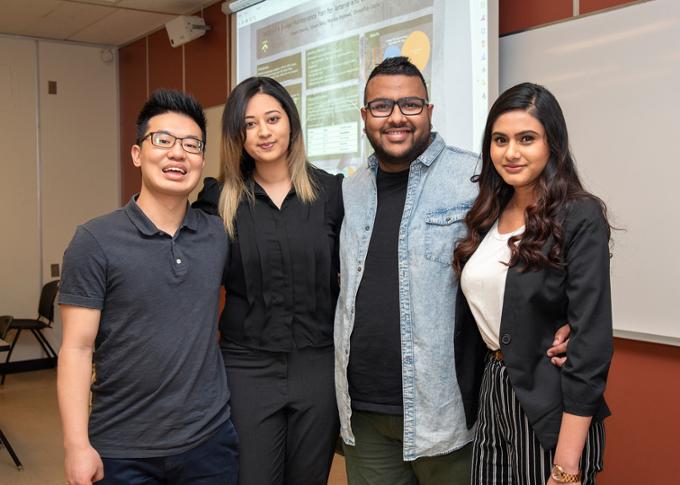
[97,419,238,485]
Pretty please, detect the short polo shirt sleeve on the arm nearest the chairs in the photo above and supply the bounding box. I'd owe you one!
[59,226,107,310]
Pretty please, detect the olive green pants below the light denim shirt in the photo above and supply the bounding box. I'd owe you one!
[343,410,472,485]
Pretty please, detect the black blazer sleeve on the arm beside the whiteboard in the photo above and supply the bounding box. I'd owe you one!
[562,200,613,416]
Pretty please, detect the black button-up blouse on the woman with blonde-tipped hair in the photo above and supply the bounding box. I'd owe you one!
[194,168,344,352]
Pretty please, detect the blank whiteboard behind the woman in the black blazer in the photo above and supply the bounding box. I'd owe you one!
[499,0,680,345]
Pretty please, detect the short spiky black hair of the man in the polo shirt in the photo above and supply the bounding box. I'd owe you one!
[135,89,206,146]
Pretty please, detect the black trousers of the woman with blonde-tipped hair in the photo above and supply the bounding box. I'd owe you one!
[222,343,339,485]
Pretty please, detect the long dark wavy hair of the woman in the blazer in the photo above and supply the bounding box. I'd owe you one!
[453,83,611,276]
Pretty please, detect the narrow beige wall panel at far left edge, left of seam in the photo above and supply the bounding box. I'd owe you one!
[0,37,40,344]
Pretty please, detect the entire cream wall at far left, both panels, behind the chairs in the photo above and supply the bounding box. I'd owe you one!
[0,37,120,360]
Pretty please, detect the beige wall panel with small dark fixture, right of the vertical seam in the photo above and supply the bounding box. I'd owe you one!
[38,42,120,352]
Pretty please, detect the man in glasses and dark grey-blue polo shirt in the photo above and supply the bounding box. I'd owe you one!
[57,91,238,485]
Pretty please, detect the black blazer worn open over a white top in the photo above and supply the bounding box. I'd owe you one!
[454,198,612,450]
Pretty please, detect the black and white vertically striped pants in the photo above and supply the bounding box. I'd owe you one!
[471,356,605,485]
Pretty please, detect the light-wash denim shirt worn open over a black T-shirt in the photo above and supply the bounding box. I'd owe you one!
[334,133,478,460]
